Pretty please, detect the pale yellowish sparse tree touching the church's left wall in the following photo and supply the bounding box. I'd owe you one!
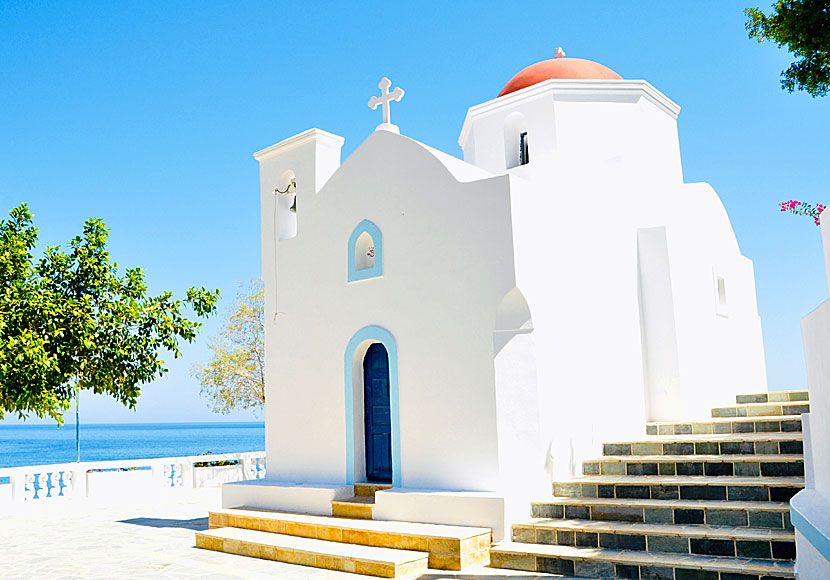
[192,281,265,414]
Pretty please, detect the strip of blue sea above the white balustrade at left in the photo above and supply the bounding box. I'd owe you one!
[0,422,265,472]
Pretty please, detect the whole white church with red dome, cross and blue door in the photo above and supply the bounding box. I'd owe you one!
[223,58,767,540]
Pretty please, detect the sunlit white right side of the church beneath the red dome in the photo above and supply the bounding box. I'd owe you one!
[459,80,767,476]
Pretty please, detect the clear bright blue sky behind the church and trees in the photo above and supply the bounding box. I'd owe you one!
[0,0,830,422]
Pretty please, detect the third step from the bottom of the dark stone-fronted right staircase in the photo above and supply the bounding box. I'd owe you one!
[531,497,792,529]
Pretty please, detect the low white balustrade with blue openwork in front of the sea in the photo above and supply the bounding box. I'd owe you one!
[0,451,265,503]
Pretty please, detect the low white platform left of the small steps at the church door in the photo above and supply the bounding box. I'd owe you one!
[222,479,354,516]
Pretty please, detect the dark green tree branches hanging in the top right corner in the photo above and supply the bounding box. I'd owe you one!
[745,0,830,97]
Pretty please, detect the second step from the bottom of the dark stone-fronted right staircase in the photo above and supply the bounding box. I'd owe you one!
[513,519,795,560]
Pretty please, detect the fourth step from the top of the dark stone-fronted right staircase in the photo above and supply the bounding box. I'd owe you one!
[602,433,804,455]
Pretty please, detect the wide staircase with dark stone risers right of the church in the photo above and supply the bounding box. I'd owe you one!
[490,391,809,580]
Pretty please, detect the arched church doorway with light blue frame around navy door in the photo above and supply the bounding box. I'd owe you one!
[344,326,401,487]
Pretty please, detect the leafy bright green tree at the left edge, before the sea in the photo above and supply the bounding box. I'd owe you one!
[0,204,219,424]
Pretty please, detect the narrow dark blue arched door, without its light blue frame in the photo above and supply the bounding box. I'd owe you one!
[363,342,392,481]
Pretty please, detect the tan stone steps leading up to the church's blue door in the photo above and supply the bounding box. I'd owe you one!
[196,484,492,578]
